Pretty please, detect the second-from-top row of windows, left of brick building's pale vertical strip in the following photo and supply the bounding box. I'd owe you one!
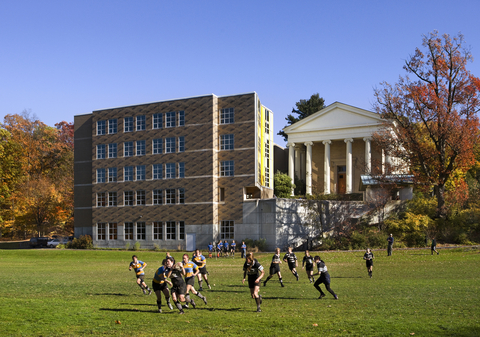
[96,137,185,159]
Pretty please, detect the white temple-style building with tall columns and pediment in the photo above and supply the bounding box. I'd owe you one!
[283,102,382,194]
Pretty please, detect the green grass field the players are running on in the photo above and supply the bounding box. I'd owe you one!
[0,248,480,337]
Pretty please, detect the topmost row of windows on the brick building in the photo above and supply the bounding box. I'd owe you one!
[97,108,235,136]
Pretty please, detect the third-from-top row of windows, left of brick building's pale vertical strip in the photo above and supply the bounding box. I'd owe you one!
[96,163,185,183]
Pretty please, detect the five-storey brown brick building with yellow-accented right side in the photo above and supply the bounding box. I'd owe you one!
[74,92,273,250]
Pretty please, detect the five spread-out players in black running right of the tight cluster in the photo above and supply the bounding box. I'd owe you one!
[242,247,338,312]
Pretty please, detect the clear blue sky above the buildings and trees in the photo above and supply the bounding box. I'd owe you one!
[0,0,480,146]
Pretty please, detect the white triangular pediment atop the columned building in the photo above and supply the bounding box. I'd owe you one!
[283,102,381,135]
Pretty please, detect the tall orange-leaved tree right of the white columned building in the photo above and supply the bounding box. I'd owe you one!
[374,31,480,217]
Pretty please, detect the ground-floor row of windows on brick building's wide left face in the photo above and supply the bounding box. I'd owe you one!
[97,221,185,240]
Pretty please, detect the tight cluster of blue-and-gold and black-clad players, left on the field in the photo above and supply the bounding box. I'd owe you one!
[129,249,212,314]
